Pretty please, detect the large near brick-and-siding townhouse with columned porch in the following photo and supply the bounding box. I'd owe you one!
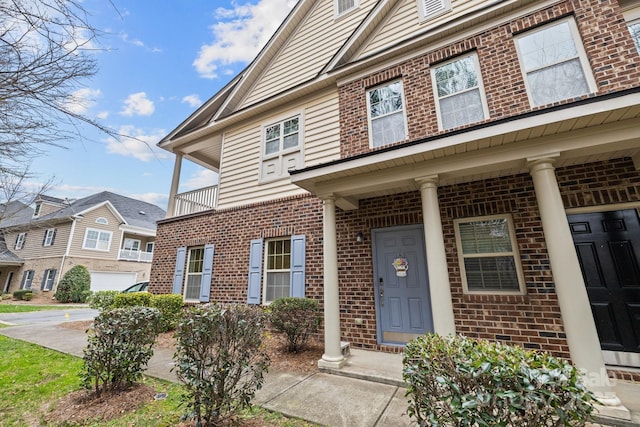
[151,0,640,416]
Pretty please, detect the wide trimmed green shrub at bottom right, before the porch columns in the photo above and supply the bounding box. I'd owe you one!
[403,334,595,427]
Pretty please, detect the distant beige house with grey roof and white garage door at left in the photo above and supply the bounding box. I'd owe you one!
[0,191,165,294]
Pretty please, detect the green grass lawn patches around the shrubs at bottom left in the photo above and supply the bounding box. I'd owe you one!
[0,335,313,427]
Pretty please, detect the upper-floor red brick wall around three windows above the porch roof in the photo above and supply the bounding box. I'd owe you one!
[339,0,640,158]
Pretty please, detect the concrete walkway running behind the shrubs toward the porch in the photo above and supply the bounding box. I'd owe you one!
[0,325,640,427]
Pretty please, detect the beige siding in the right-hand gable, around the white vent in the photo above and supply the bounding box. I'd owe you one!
[359,0,487,57]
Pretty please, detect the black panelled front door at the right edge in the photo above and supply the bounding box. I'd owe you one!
[568,209,640,353]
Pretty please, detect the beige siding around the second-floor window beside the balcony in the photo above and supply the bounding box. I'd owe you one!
[218,92,340,209]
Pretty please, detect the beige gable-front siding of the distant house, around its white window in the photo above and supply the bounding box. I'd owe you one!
[69,206,122,260]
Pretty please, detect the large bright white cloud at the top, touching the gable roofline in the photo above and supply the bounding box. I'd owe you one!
[193,0,296,79]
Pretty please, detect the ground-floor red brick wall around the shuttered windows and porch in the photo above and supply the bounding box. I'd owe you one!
[151,159,640,357]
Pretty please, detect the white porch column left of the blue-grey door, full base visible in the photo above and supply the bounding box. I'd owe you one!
[318,196,346,369]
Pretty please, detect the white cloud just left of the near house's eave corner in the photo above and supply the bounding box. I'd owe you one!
[106,126,169,162]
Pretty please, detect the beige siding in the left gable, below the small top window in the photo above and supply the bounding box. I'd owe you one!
[239,0,376,108]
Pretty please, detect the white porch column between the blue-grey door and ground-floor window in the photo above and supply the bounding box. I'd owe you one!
[416,176,456,335]
